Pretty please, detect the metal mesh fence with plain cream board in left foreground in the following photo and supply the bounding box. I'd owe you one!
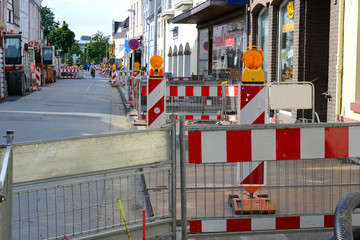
[0,125,176,240]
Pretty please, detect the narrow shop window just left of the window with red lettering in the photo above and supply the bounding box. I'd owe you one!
[198,29,209,80]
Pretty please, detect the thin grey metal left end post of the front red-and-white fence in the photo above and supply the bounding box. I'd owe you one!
[179,116,187,240]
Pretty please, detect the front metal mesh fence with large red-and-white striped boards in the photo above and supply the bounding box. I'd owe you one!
[180,119,360,239]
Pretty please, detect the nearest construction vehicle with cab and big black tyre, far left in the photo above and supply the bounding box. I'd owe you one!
[4,33,30,95]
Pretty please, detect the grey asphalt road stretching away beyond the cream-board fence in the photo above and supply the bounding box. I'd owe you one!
[0,72,130,142]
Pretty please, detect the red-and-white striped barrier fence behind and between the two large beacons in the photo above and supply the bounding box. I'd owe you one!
[134,79,238,121]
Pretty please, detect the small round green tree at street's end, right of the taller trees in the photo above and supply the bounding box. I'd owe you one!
[86,31,110,64]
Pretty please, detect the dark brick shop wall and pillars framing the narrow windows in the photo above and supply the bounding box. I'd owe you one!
[249,0,331,121]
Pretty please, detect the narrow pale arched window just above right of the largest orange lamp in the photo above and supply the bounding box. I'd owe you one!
[258,8,269,80]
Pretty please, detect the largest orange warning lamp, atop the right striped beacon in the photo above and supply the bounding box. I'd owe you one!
[242,46,265,83]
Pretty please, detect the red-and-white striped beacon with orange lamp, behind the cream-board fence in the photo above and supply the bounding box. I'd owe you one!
[147,55,166,128]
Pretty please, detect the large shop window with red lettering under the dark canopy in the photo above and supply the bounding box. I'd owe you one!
[211,20,244,80]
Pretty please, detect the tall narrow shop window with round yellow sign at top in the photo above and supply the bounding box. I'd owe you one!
[279,0,295,82]
